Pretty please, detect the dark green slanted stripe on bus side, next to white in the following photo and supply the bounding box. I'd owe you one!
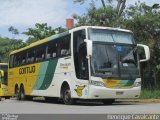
[39,59,58,90]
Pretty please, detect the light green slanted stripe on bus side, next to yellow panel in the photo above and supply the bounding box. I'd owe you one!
[34,61,49,90]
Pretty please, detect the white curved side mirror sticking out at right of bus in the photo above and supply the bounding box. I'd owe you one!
[137,44,150,62]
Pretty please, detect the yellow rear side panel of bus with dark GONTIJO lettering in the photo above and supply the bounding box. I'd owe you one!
[8,63,40,96]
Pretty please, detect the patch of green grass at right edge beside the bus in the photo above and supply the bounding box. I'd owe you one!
[140,90,160,99]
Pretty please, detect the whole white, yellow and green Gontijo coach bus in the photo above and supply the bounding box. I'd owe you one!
[8,26,150,104]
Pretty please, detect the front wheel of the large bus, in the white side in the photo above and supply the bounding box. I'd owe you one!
[63,86,75,105]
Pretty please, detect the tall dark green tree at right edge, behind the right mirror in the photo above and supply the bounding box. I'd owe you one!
[124,2,160,89]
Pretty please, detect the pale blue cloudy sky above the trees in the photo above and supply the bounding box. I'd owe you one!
[0,0,160,40]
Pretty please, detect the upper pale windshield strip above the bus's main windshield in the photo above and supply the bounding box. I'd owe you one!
[89,29,134,44]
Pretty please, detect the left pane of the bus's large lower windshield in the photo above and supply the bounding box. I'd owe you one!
[91,43,118,77]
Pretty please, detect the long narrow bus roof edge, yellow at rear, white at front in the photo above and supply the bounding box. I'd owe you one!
[10,26,132,55]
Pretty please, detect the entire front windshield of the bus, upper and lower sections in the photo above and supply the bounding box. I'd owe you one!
[89,29,140,79]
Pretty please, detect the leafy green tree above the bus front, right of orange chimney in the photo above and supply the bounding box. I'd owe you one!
[73,2,123,27]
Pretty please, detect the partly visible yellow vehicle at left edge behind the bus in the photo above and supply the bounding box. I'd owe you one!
[0,63,10,98]
